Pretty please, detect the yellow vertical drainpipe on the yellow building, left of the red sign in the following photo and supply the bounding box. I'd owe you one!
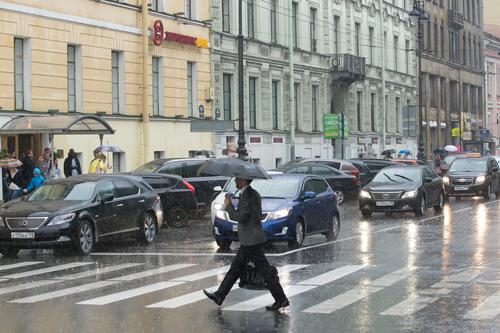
[140,0,150,164]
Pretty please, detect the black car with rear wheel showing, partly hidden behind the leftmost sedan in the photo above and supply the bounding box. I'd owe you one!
[135,173,197,228]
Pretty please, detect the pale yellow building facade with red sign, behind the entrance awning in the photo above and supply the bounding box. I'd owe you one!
[0,0,213,171]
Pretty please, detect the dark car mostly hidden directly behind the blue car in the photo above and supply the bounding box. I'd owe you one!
[283,163,360,205]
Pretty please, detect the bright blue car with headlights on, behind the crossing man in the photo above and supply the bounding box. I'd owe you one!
[212,174,340,249]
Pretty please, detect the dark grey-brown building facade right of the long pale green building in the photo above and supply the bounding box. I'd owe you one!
[422,0,486,158]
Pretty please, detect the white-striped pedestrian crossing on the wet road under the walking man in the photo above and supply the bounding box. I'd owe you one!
[0,261,500,320]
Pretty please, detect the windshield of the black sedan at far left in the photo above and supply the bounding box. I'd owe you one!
[28,182,96,201]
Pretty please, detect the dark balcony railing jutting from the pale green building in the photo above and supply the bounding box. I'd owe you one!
[332,54,366,83]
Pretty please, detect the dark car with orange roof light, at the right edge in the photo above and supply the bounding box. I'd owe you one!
[443,157,500,200]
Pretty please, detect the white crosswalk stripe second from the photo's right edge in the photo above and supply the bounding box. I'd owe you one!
[380,269,482,316]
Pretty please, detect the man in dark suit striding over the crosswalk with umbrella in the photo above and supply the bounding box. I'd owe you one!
[200,158,290,310]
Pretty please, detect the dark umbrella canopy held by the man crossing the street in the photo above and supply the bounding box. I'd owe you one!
[200,158,271,179]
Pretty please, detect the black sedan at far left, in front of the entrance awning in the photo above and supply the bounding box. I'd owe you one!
[0,175,163,256]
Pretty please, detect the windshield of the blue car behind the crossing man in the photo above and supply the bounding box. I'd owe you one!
[224,178,300,199]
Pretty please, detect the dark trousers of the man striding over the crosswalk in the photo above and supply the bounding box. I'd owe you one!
[217,244,286,301]
